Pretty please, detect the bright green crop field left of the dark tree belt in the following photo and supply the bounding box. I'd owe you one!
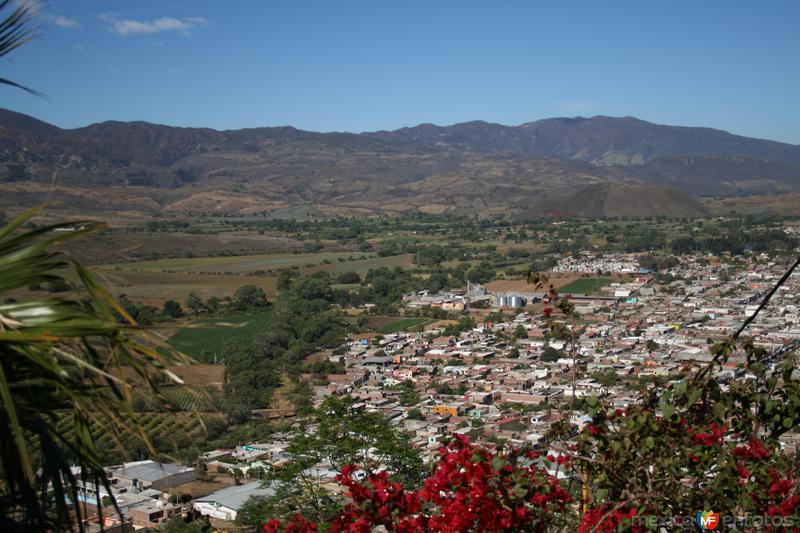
[169,312,270,362]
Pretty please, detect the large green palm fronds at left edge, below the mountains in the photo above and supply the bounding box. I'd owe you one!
[0,208,187,531]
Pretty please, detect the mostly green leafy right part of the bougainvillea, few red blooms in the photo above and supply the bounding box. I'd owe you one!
[578,339,800,519]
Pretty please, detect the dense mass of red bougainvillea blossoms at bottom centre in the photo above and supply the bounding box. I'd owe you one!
[263,435,571,533]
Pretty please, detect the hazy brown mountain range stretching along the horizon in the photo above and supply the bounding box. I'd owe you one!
[0,110,800,217]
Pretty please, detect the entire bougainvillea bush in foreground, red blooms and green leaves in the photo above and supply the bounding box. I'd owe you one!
[263,272,800,533]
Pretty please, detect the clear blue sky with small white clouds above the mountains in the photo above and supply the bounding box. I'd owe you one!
[0,0,800,144]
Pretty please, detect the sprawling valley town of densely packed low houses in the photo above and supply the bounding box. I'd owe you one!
[81,254,800,531]
